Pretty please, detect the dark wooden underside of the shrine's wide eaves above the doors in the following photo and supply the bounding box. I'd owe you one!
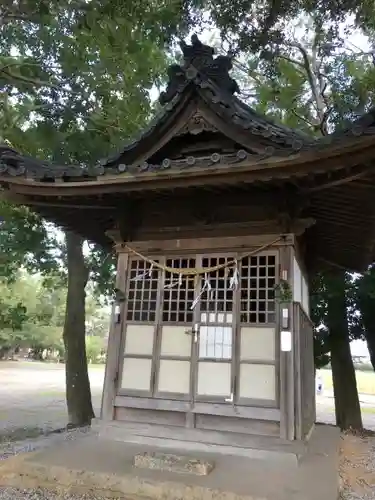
[2,175,375,271]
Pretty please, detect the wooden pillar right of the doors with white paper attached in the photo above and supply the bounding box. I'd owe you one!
[279,245,295,440]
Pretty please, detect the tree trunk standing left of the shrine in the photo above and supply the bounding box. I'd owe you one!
[63,231,95,427]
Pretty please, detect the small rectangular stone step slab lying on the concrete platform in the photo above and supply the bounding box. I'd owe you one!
[133,451,215,476]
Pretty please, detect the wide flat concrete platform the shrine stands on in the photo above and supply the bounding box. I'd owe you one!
[0,426,340,500]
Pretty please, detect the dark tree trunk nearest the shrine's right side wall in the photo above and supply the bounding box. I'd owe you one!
[326,271,362,429]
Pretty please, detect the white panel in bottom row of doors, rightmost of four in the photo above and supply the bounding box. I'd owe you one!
[240,363,276,401]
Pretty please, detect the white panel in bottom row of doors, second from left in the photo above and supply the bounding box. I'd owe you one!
[158,359,190,394]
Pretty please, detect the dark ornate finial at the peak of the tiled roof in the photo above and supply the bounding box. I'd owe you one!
[159,34,239,105]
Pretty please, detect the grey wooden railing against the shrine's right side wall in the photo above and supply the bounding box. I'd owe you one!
[293,302,316,439]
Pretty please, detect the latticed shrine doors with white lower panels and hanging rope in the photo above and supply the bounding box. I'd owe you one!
[120,251,279,408]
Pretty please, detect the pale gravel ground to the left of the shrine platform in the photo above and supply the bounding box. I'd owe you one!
[0,362,106,500]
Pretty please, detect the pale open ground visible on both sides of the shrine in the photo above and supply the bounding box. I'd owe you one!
[0,362,375,500]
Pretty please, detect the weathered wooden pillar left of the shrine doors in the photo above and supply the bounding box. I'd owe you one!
[100,253,129,421]
